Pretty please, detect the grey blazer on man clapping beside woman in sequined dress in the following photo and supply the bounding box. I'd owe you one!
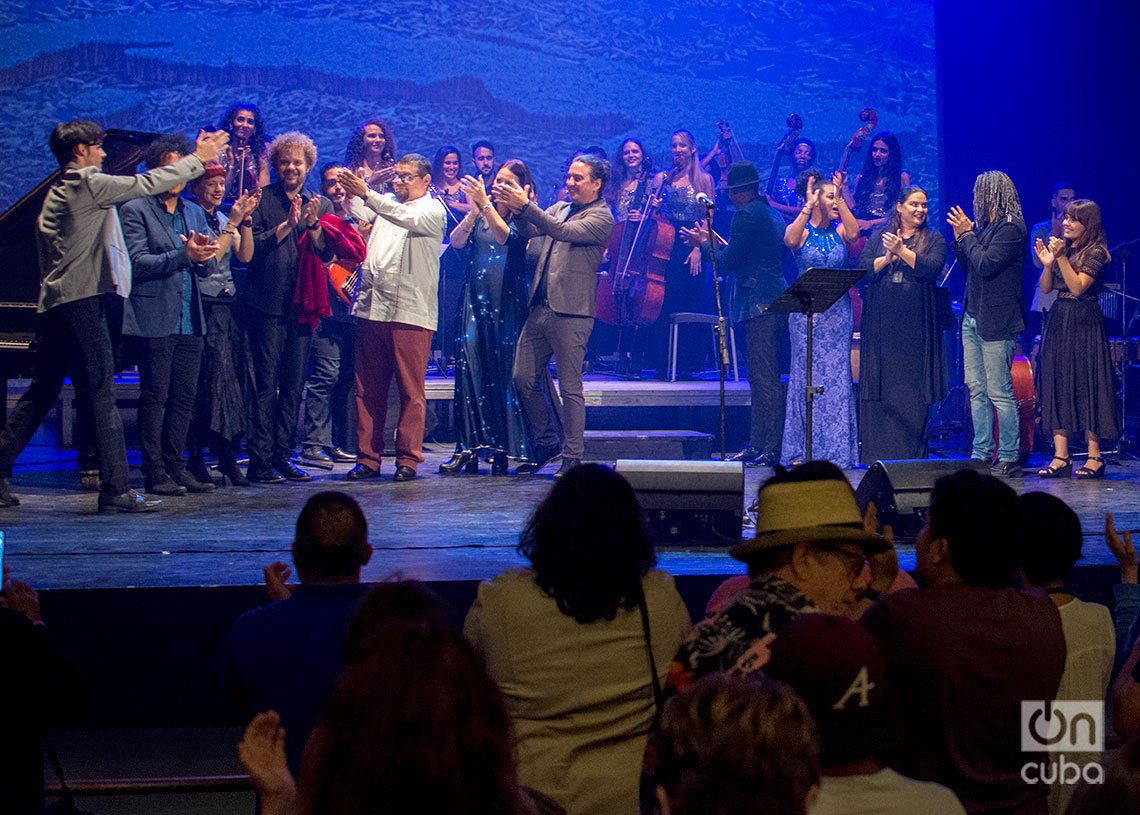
[519,198,613,317]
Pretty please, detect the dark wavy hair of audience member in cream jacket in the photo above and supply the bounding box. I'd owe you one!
[519,464,657,622]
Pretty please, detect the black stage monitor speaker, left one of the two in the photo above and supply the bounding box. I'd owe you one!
[617,458,744,546]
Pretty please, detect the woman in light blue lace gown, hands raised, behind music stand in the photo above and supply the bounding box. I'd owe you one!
[780,170,858,467]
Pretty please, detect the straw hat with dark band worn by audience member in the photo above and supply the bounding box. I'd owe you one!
[728,479,890,561]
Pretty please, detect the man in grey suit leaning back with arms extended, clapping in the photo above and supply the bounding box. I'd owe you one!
[494,155,613,479]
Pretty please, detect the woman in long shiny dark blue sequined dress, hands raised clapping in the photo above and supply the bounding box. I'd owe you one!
[439,158,554,475]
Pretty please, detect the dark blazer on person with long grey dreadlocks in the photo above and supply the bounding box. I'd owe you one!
[954,215,1027,342]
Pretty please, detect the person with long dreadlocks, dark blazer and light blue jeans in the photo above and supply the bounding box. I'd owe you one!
[946,171,1026,478]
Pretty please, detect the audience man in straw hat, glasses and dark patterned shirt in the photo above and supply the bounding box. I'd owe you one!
[667,462,894,692]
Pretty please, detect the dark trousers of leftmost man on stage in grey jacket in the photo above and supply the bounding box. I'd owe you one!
[0,295,129,495]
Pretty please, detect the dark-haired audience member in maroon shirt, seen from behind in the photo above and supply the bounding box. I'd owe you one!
[863,470,1065,814]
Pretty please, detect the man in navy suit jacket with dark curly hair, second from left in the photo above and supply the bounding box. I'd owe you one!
[120,136,218,496]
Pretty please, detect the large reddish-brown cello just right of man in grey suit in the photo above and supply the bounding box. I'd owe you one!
[594,177,676,327]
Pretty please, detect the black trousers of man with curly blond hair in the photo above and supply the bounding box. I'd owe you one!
[246,308,312,467]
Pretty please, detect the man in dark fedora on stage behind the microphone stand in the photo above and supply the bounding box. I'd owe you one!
[681,162,788,466]
